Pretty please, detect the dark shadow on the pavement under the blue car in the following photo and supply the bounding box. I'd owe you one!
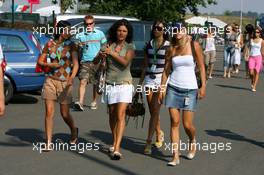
[9,94,38,104]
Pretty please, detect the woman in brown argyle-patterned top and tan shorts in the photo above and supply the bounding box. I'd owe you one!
[38,21,79,151]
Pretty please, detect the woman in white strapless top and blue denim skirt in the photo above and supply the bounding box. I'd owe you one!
[159,24,206,166]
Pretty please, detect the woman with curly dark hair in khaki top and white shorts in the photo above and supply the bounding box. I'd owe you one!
[100,19,135,160]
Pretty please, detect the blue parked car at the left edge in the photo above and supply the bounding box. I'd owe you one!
[0,28,45,102]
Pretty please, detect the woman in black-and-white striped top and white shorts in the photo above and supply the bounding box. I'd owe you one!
[139,20,170,154]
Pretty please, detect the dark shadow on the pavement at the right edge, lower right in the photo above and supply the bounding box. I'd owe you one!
[205,129,264,148]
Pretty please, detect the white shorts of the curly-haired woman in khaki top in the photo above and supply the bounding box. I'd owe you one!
[102,84,134,105]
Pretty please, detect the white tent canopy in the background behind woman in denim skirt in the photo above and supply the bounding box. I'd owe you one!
[185,16,227,28]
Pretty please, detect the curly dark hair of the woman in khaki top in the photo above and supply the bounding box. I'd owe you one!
[108,19,133,43]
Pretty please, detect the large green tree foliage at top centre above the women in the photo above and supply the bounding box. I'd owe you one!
[82,0,216,21]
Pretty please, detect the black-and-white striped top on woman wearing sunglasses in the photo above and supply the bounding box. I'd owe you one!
[146,40,170,74]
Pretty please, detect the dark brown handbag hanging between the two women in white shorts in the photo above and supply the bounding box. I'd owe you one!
[126,92,146,128]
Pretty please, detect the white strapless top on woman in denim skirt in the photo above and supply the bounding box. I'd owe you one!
[168,55,198,89]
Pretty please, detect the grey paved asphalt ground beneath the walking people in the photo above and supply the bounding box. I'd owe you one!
[0,54,264,175]
